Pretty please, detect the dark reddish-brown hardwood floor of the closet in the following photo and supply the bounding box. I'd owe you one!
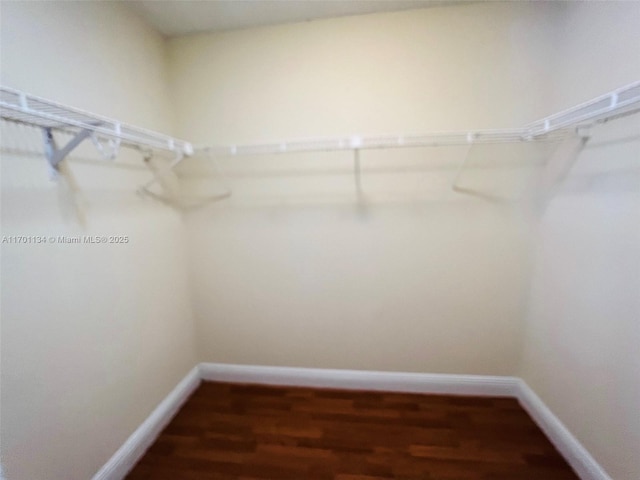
[127,382,578,480]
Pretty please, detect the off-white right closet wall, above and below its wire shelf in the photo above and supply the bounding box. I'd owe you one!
[522,2,640,480]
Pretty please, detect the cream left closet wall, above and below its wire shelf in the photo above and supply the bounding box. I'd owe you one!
[0,2,196,480]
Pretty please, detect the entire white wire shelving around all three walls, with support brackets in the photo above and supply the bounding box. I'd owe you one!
[0,81,640,206]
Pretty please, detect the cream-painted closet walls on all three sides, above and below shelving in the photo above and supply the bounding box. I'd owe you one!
[0,2,640,480]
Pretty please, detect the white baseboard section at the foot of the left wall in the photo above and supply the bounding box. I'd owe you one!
[92,366,200,480]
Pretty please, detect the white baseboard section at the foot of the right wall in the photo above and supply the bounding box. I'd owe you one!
[518,380,612,480]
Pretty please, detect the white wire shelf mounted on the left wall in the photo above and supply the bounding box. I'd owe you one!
[0,86,193,156]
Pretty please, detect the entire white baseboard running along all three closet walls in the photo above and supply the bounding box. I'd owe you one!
[92,363,612,480]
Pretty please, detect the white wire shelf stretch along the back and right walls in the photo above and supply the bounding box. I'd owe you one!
[195,81,640,157]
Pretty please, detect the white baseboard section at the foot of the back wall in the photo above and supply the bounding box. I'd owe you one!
[199,363,519,397]
